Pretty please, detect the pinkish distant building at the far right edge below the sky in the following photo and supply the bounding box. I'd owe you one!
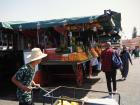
[122,36,140,48]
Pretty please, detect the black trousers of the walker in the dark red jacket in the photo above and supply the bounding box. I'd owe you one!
[105,70,117,93]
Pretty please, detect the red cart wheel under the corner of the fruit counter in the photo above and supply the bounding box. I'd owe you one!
[76,65,83,87]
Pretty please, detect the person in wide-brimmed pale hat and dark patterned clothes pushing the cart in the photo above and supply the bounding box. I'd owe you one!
[11,48,47,105]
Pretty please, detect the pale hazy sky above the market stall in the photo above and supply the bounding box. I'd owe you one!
[0,0,140,38]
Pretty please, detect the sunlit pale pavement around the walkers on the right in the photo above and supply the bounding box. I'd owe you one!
[91,58,140,105]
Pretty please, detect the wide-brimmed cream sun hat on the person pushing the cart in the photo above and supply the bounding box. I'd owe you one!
[27,48,47,63]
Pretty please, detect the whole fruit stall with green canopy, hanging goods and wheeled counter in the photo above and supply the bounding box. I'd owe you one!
[9,10,121,86]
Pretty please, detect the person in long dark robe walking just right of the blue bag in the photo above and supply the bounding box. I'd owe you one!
[120,46,132,80]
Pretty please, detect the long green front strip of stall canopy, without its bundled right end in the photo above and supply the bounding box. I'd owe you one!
[12,16,97,30]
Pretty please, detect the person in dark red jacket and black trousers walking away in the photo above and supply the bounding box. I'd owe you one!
[101,42,117,97]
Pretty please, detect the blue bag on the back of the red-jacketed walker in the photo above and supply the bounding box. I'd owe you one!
[112,52,122,69]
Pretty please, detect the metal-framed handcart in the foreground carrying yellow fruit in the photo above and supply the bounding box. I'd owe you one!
[43,86,120,105]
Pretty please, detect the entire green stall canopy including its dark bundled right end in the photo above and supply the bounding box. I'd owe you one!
[11,10,121,32]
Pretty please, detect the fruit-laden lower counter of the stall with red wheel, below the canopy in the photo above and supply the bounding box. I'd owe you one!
[37,41,101,86]
